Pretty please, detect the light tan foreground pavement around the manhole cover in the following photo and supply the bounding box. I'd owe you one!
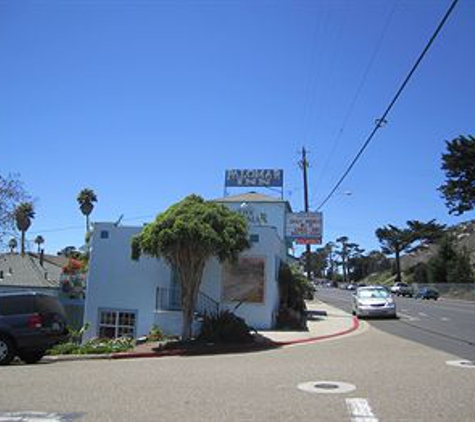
[0,302,475,422]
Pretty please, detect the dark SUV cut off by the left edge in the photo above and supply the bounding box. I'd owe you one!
[0,292,67,365]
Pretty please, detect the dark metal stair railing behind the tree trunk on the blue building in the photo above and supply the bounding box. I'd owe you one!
[155,286,219,316]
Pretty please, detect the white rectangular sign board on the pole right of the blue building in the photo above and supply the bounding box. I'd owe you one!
[286,212,323,245]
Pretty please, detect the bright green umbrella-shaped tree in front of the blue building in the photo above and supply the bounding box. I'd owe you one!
[132,195,249,340]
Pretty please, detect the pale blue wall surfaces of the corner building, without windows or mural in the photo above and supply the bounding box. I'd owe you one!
[84,203,286,338]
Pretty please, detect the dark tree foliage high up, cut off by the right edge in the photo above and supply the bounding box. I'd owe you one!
[439,135,475,215]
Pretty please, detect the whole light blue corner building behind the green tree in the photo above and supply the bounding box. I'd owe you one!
[84,193,291,338]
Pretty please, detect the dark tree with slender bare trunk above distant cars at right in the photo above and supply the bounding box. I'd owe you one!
[376,224,415,281]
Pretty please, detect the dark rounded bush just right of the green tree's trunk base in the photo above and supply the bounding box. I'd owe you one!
[198,311,253,343]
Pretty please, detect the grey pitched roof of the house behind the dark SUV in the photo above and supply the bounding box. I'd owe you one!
[0,253,63,288]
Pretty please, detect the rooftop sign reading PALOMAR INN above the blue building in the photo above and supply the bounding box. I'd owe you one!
[225,169,284,188]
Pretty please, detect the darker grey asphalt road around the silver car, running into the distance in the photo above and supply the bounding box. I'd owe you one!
[316,287,475,361]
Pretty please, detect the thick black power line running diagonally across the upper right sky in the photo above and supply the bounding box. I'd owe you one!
[317,0,459,211]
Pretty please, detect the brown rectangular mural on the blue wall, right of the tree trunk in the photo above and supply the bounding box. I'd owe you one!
[223,257,265,303]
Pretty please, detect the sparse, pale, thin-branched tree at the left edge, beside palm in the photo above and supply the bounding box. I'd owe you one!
[0,174,28,243]
